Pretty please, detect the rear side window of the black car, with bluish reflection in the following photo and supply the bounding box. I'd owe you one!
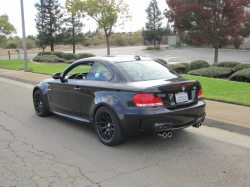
[87,62,112,81]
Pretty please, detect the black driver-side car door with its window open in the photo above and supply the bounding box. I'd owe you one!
[50,64,90,116]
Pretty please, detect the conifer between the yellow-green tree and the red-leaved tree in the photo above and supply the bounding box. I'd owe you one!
[142,0,166,48]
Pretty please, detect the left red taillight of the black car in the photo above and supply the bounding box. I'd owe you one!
[133,94,163,107]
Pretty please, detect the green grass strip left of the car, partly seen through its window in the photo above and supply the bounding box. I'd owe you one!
[0,60,90,75]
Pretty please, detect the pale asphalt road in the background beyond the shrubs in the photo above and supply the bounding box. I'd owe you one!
[0,46,250,64]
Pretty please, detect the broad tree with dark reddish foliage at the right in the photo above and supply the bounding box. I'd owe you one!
[164,0,248,64]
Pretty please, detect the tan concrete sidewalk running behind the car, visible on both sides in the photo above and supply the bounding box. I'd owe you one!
[0,68,250,135]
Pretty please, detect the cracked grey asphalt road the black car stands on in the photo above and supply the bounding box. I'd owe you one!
[0,78,250,187]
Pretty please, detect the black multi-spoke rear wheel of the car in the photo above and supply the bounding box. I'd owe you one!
[95,106,124,146]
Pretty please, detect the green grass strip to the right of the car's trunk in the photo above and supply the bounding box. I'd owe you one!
[182,75,250,106]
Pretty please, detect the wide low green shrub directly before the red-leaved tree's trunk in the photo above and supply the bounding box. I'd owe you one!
[188,67,233,78]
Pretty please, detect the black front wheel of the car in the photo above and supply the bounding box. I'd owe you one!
[33,90,49,117]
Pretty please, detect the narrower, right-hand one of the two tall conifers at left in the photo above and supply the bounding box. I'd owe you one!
[64,0,84,54]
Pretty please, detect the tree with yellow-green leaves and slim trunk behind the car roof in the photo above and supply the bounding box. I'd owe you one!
[73,0,131,55]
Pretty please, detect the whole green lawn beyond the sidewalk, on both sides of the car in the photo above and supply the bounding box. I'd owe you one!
[0,60,250,106]
